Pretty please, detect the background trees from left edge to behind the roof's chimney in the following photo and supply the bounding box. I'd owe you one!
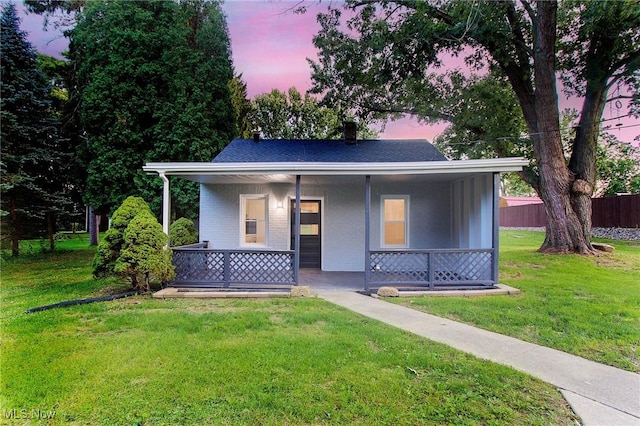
[2,0,375,255]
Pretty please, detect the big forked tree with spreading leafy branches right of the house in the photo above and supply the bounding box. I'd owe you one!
[312,0,640,253]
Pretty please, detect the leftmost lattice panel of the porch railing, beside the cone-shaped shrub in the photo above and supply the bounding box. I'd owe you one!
[173,250,224,282]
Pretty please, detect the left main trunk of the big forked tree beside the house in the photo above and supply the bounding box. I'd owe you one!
[530,1,592,253]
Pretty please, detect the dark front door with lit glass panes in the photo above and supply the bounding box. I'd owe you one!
[291,200,322,268]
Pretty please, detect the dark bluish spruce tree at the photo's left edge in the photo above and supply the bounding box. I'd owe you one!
[0,4,67,256]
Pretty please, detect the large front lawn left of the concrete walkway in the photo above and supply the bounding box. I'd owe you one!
[0,235,575,425]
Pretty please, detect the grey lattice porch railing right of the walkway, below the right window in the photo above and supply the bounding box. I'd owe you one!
[366,249,496,290]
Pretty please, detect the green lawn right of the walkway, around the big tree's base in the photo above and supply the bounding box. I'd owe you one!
[394,230,640,372]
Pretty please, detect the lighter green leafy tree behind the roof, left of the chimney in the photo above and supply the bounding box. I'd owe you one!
[249,87,376,139]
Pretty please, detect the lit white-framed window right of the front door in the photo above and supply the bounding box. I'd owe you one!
[381,195,409,247]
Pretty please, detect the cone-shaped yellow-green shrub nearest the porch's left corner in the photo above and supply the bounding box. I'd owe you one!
[114,210,175,292]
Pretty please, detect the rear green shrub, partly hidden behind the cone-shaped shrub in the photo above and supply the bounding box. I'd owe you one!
[93,197,151,277]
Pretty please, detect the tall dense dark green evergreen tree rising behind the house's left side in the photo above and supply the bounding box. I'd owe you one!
[70,0,235,216]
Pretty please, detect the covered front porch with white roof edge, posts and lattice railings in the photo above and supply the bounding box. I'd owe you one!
[145,159,523,291]
